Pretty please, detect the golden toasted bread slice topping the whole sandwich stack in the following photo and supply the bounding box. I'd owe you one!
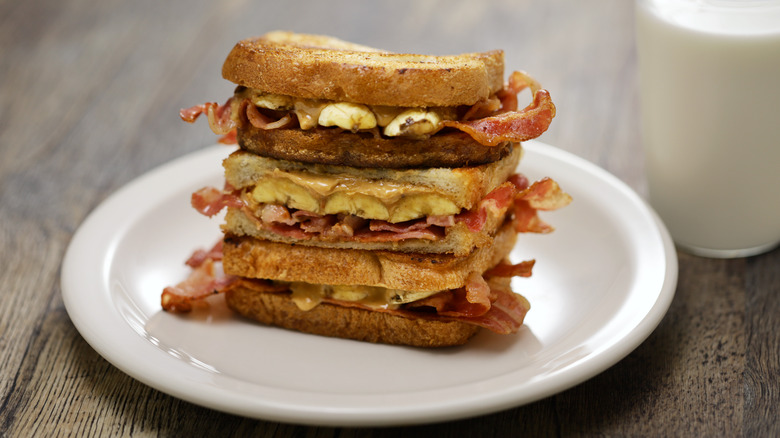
[222,32,504,107]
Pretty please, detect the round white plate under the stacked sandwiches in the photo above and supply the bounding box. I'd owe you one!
[62,142,677,426]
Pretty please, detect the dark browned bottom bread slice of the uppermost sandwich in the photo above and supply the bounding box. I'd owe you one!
[238,124,519,169]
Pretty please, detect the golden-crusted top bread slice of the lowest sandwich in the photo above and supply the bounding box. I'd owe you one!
[222,219,517,291]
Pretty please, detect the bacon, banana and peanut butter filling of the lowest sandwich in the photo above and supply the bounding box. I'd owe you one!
[161,241,534,334]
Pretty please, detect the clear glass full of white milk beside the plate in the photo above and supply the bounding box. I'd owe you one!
[636,0,780,258]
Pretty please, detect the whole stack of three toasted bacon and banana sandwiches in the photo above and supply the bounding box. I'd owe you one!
[161,31,571,347]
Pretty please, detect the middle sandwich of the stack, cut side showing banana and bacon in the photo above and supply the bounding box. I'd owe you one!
[186,146,570,255]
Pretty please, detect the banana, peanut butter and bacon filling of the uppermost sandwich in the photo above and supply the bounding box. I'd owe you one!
[179,72,555,146]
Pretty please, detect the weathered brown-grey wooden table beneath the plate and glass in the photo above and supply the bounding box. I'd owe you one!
[0,0,780,437]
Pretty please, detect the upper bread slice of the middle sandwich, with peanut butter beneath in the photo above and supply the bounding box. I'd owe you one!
[223,146,522,219]
